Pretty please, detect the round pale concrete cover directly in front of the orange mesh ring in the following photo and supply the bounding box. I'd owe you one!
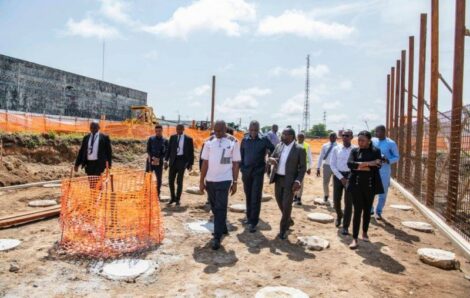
[103,259,153,280]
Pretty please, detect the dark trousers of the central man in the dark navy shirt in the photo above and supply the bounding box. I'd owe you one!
[242,173,264,226]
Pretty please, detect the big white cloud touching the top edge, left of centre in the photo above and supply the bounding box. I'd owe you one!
[142,0,256,39]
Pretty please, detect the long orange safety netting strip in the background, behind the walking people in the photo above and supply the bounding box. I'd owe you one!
[0,111,243,148]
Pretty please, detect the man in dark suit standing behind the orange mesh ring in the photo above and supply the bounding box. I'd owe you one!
[75,122,112,176]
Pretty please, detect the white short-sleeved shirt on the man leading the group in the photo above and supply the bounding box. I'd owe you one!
[201,138,242,182]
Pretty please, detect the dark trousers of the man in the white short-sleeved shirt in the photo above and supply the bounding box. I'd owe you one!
[206,181,232,240]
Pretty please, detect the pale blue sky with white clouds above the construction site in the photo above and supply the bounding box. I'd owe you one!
[0,0,470,132]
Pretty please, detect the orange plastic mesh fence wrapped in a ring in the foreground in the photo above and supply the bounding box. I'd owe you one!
[60,169,164,258]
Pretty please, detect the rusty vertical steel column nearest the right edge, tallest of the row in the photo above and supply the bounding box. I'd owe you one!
[446,0,466,222]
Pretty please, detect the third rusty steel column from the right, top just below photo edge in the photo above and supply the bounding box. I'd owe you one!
[413,13,428,197]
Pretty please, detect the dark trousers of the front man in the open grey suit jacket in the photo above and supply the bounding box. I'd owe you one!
[274,175,294,233]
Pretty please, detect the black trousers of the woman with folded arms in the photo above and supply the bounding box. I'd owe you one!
[351,184,375,239]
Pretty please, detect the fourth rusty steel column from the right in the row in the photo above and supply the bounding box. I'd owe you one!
[404,36,416,187]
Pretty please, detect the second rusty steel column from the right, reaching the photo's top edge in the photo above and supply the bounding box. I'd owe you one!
[426,0,439,206]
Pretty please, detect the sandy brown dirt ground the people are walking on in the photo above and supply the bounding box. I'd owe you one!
[0,152,470,297]
